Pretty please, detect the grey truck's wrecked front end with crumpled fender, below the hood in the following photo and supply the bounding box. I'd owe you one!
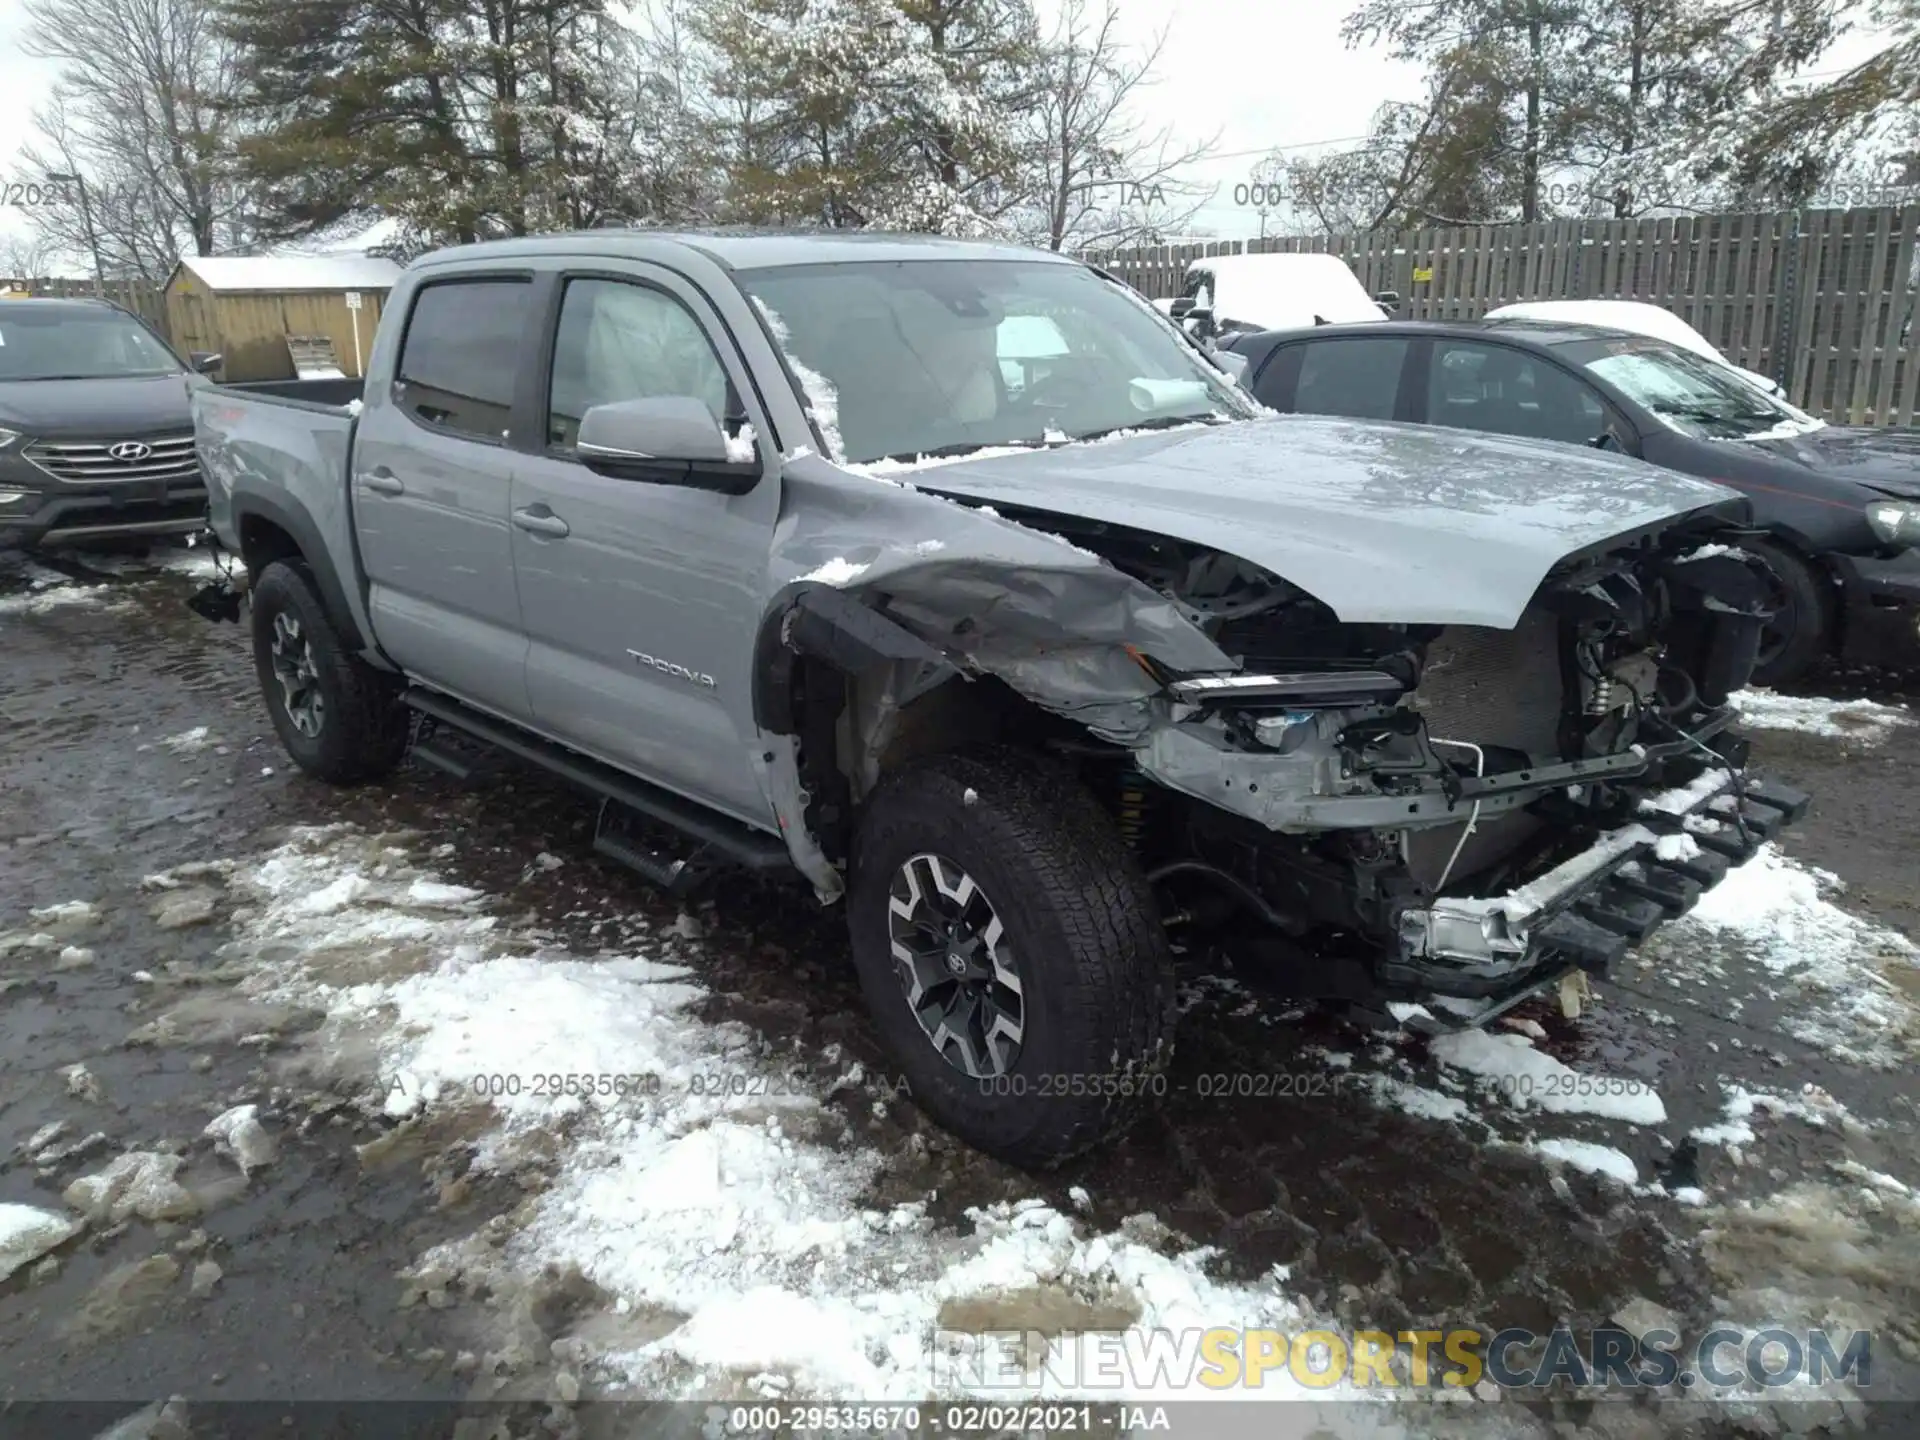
[756,433,1807,1029]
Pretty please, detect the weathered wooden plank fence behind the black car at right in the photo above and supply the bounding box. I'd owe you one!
[1100,205,1920,424]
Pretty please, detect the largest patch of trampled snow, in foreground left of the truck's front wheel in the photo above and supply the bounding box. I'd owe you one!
[194,826,1374,1400]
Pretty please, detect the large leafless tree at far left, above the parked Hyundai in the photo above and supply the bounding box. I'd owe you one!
[21,0,248,280]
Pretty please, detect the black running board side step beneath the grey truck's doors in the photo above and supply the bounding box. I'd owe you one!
[401,685,793,879]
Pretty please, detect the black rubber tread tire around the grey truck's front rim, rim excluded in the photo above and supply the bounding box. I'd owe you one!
[847,749,1175,1167]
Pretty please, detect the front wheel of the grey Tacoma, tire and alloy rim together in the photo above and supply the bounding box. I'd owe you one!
[847,751,1173,1165]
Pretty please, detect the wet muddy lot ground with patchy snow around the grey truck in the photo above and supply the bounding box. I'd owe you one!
[0,551,1920,1436]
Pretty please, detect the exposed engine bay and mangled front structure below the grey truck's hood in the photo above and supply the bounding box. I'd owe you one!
[1013,520,1803,1023]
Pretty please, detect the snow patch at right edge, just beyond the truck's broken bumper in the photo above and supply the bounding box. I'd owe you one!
[1642,845,1920,1069]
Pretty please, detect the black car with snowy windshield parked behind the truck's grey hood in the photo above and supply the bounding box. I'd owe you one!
[1217,319,1920,684]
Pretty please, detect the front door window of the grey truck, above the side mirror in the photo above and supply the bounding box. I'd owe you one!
[547,280,739,447]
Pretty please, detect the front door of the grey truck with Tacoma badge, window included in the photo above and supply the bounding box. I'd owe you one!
[509,263,780,826]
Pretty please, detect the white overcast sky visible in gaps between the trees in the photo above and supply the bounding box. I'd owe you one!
[0,0,1872,268]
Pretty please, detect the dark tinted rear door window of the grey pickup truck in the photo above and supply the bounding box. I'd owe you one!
[394,280,534,444]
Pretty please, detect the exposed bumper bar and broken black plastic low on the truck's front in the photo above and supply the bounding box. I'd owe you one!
[1379,770,1809,1031]
